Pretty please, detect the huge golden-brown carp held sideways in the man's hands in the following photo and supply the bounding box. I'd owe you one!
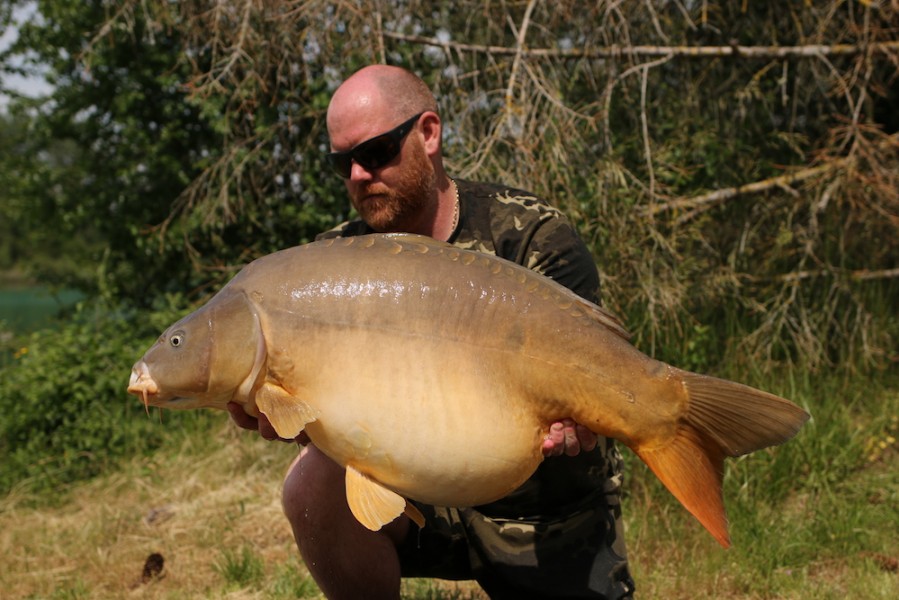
[128,234,809,547]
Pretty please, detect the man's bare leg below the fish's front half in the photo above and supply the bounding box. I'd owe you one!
[282,444,409,600]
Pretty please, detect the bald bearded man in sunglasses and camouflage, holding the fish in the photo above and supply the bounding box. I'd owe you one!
[229,65,633,598]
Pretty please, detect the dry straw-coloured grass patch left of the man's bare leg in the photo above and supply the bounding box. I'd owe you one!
[0,425,296,598]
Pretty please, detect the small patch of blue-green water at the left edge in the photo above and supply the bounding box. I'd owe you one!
[0,286,82,333]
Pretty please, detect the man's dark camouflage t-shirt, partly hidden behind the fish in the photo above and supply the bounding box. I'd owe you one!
[317,180,621,519]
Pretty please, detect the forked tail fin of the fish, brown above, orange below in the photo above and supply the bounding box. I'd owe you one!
[635,369,809,548]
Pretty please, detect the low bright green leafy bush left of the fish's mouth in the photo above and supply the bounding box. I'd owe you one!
[0,297,216,493]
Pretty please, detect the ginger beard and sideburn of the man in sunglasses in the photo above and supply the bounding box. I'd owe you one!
[351,137,437,232]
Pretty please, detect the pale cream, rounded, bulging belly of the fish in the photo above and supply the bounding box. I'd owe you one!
[278,332,545,506]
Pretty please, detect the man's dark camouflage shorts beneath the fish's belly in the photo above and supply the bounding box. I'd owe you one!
[399,497,634,598]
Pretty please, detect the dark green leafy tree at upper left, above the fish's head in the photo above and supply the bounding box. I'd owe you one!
[1,0,346,305]
